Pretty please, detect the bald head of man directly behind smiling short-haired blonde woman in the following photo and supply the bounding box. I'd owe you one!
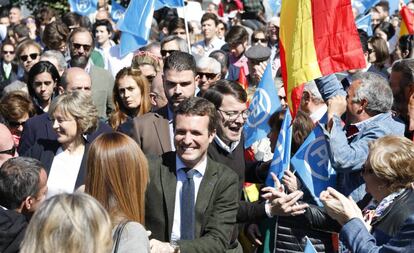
[60,67,92,95]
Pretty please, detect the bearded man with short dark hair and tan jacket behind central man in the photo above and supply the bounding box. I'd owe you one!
[119,51,198,155]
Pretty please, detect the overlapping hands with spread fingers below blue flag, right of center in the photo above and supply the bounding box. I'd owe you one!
[262,173,308,216]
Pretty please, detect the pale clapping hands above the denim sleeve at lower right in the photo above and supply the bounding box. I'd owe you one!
[319,187,364,225]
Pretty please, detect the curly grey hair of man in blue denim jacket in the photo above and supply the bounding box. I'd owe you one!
[352,72,394,115]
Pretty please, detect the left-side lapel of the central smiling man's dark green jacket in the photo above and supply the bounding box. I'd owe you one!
[160,152,177,235]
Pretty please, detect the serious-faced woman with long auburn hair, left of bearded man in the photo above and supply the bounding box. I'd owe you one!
[109,68,151,129]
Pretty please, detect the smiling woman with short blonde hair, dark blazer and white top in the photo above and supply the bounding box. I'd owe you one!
[24,91,98,197]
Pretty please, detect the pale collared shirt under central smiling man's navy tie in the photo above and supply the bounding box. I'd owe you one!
[171,155,207,241]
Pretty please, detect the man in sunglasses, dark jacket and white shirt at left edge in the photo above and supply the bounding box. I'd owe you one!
[0,42,18,94]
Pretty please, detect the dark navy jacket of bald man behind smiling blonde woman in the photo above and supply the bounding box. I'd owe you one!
[18,113,112,154]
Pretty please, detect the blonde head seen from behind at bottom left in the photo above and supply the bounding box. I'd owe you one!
[20,193,112,253]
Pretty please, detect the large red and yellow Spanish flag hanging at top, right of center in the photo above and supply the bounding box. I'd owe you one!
[279,0,365,115]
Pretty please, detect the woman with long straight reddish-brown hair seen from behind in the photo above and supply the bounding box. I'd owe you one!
[85,132,149,252]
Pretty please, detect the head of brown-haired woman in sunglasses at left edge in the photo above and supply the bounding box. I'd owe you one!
[0,91,36,147]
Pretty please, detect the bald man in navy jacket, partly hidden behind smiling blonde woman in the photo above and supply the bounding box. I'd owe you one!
[18,67,112,154]
